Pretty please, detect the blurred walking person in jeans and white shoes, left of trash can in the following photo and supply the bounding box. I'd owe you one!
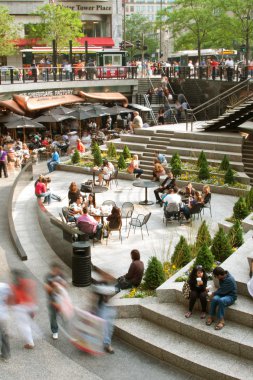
[44,263,66,340]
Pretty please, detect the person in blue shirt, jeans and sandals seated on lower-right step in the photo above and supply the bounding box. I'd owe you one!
[206,267,237,330]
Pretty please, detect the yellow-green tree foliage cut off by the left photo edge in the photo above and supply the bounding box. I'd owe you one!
[0,6,20,56]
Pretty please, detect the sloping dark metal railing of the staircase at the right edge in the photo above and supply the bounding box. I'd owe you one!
[186,79,253,131]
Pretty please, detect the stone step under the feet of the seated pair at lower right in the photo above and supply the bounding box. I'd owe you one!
[141,303,253,360]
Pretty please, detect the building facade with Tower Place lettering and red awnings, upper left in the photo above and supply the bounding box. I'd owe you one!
[0,0,122,66]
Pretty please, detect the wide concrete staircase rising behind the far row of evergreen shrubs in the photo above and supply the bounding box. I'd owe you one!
[106,127,247,179]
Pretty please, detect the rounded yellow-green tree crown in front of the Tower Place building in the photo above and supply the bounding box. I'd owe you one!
[35,3,83,51]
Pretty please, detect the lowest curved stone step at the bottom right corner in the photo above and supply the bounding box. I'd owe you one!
[115,318,252,380]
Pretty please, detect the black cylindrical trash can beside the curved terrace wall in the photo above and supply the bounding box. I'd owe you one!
[72,241,91,287]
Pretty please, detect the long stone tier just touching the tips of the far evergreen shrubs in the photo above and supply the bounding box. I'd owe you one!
[166,146,242,162]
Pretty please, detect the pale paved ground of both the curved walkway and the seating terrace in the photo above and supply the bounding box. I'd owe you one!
[0,156,239,379]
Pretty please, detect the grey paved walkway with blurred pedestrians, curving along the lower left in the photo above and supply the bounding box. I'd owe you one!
[0,165,204,380]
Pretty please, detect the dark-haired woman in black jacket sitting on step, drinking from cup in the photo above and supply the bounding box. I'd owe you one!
[185,265,207,319]
